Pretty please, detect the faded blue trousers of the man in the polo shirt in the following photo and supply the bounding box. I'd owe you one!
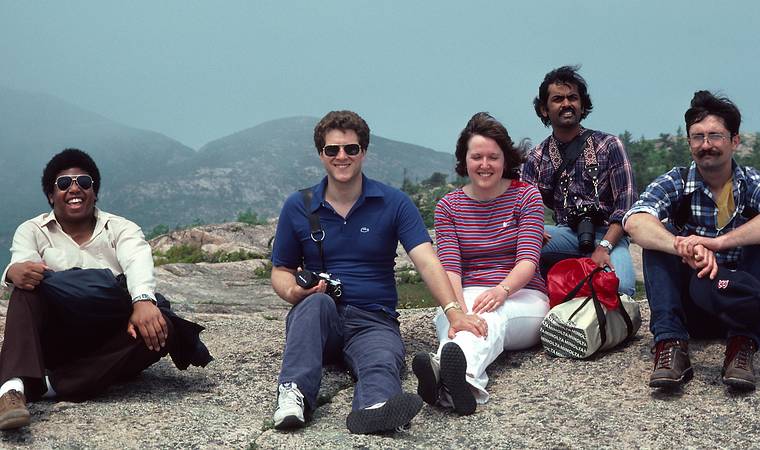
[279,294,405,411]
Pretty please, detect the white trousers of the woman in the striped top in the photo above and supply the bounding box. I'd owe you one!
[433,286,549,406]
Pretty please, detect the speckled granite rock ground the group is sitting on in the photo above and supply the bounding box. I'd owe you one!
[0,227,760,449]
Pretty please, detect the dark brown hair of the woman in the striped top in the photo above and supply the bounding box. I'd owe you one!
[454,112,525,180]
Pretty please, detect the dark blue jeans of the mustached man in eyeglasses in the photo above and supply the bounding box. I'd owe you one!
[642,246,760,342]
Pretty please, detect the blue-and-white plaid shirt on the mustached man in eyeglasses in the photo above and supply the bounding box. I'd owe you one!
[623,161,760,264]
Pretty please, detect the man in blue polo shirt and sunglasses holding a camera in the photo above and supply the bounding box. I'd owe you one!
[272,111,487,433]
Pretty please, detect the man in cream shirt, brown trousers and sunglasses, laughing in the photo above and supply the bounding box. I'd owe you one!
[0,149,211,430]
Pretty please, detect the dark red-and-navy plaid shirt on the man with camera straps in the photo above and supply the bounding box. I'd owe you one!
[521,130,636,225]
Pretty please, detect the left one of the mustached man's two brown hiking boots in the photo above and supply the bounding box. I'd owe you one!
[649,339,694,389]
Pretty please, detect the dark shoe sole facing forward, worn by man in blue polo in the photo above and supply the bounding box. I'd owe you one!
[346,392,422,434]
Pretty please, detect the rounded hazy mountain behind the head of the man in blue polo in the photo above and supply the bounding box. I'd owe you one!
[118,117,454,229]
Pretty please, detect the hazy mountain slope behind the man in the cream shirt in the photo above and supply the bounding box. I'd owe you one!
[0,87,196,266]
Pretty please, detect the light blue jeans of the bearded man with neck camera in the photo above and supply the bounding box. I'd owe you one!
[541,225,636,296]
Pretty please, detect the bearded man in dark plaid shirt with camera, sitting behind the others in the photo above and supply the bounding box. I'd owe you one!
[522,66,636,295]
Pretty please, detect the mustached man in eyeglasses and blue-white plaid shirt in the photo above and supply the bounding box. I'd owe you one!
[623,91,760,390]
